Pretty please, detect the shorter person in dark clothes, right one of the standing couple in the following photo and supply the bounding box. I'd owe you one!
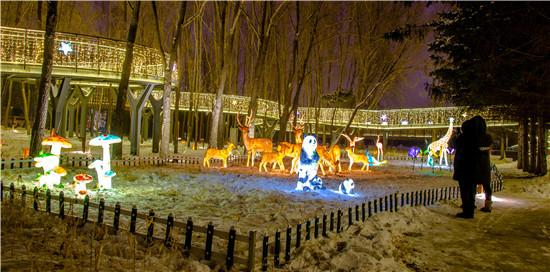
[471,115,493,212]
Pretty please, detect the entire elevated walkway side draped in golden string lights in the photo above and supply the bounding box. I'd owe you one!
[0,27,517,130]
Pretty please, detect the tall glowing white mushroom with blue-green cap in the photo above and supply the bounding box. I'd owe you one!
[88,134,122,189]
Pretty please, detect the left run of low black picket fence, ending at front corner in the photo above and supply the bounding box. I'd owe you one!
[0,182,256,271]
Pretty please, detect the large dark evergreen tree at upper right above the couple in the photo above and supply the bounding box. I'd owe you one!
[387,2,550,175]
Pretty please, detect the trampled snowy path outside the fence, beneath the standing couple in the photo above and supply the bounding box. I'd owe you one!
[282,165,550,271]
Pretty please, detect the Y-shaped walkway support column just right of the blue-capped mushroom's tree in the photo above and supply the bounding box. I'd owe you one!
[128,84,155,155]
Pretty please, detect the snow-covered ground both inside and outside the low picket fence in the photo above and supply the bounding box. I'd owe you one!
[1,128,550,271]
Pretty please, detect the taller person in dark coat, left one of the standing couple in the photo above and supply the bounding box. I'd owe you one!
[453,120,476,218]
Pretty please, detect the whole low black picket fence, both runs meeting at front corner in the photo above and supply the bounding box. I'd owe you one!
[0,159,503,271]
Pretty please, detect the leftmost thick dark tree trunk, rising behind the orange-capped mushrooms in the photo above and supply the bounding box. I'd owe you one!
[30,1,57,157]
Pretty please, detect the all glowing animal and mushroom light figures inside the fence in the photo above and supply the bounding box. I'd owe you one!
[30,114,460,197]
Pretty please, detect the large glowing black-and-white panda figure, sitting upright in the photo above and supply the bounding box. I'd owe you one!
[296,135,325,191]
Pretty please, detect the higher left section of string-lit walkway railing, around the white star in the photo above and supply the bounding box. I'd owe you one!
[0,27,168,80]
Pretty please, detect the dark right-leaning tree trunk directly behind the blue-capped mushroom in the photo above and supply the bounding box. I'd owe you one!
[111,1,141,158]
